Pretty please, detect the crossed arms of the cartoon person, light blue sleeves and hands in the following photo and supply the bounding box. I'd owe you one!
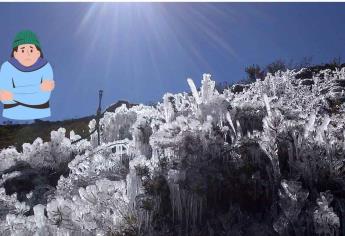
[0,65,55,105]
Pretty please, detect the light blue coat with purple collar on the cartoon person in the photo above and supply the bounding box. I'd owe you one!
[0,58,53,120]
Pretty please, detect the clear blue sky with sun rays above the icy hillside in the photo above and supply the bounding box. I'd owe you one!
[0,3,345,121]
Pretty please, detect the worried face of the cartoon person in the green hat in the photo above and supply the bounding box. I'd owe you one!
[13,44,41,67]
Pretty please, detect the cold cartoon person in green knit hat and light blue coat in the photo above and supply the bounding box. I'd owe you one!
[0,30,55,120]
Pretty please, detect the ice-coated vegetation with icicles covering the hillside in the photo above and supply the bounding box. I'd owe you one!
[0,68,345,236]
